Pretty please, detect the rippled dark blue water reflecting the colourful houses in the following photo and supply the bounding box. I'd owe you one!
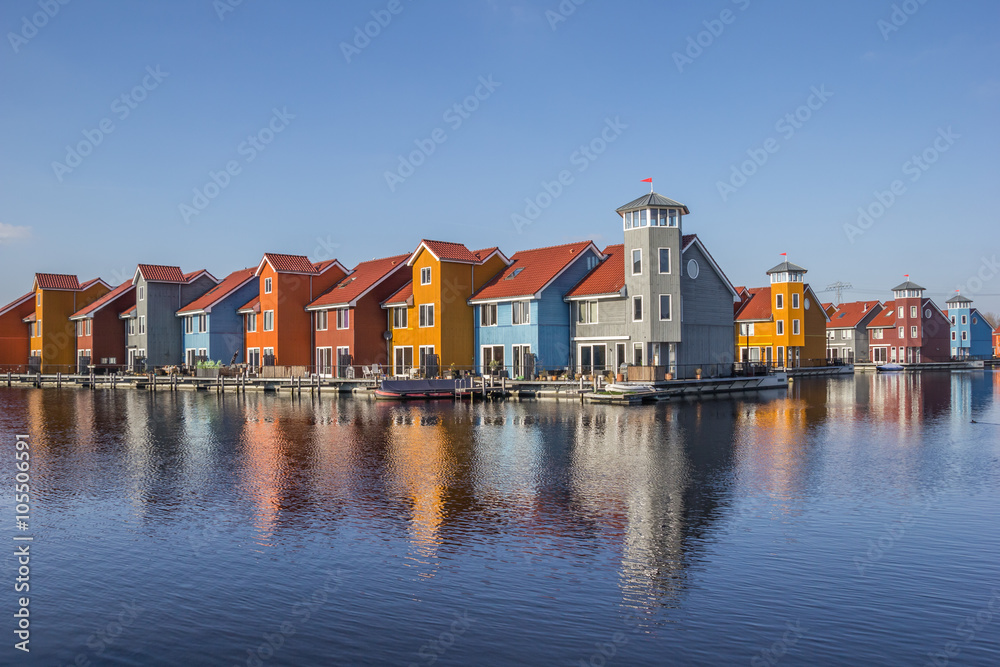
[0,372,1000,665]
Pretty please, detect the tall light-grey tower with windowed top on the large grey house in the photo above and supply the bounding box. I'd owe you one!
[616,192,690,372]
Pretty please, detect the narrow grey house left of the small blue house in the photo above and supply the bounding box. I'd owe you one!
[120,264,219,370]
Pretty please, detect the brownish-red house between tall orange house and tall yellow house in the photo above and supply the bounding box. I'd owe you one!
[306,255,411,377]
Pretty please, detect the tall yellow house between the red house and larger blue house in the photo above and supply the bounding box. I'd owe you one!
[382,240,510,377]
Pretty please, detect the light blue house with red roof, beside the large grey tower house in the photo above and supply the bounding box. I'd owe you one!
[469,241,604,378]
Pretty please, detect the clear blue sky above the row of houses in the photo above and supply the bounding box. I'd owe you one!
[0,0,1000,311]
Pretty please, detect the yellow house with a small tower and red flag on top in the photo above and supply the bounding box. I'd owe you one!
[735,261,830,368]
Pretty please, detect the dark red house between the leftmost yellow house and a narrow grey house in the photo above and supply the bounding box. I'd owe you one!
[70,280,135,373]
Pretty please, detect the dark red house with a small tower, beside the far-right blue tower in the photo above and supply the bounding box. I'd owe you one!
[868,276,951,364]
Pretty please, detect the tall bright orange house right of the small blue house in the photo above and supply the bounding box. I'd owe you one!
[238,252,347,368]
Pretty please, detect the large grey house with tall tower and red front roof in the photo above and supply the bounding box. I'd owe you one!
[565,193,738,380]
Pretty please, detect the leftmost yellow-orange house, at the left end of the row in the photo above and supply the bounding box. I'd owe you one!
[25,273,111,373]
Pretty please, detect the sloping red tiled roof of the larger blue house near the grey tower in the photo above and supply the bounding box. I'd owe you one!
[469,241,603,303]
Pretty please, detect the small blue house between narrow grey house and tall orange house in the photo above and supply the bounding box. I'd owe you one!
[177,269,260,366]
